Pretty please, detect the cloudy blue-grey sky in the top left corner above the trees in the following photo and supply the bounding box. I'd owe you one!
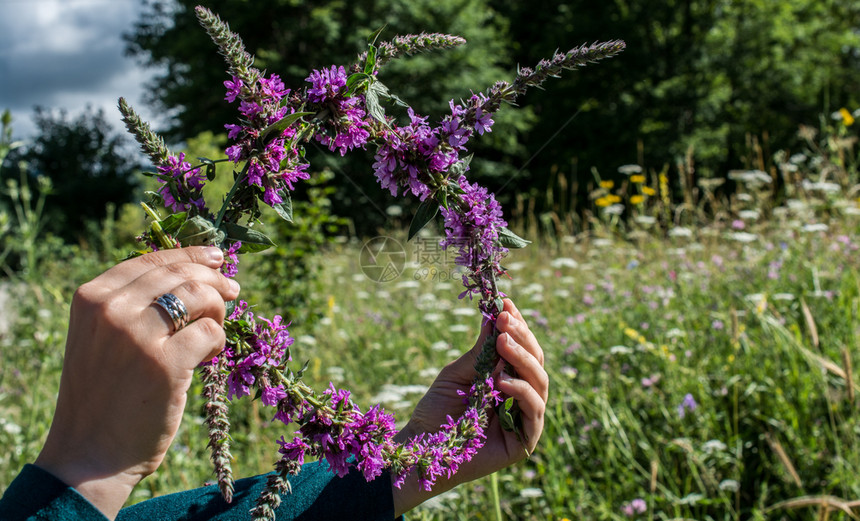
[0,0,157,140]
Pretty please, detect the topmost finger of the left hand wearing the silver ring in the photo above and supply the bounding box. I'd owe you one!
[90,246,224,291]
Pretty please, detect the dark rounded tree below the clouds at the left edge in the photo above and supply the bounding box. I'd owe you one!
[3,107,139,241]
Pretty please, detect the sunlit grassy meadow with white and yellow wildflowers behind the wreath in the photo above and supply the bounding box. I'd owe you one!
[0,112,860,520]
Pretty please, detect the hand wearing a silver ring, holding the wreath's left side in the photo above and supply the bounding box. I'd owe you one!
[35,247,239,519]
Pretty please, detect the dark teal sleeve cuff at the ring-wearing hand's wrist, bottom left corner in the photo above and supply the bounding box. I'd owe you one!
[0,464,107,521]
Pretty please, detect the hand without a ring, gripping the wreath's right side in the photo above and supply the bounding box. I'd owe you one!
[392,299,549,515]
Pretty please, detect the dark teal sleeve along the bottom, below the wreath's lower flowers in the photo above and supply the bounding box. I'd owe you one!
[117,462,402,521]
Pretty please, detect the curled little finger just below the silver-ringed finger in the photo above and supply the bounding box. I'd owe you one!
[164,317,226,371]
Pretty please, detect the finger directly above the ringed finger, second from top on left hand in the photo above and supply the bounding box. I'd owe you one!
[121,262,239,308]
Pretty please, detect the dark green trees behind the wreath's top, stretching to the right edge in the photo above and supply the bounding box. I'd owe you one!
[127,0,860,231]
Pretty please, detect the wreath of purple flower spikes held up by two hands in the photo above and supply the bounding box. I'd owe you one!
[119,7,625,519]
